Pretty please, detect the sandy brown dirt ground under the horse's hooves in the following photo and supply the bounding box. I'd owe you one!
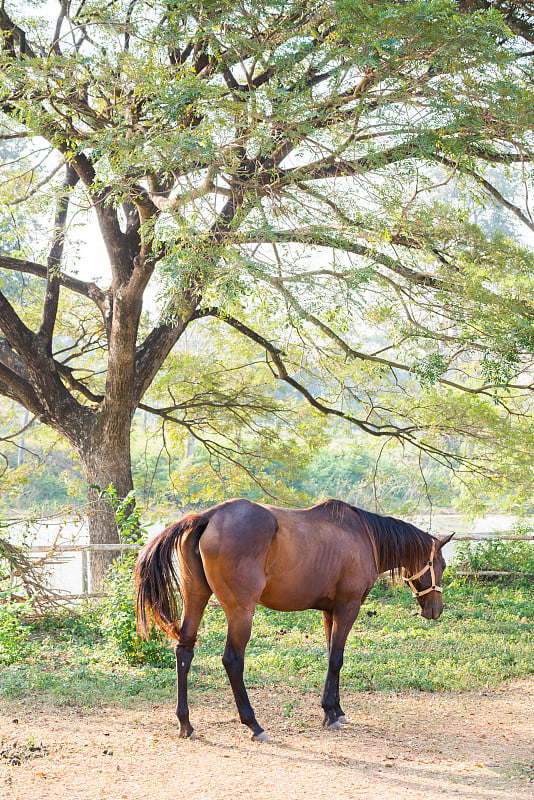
[0,679,534,800]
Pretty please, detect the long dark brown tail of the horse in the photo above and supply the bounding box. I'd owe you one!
[134,514,209,639]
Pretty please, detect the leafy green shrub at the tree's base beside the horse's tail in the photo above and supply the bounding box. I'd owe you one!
[100,554,174,667]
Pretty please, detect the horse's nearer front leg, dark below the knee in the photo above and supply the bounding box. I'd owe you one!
[321,603,360,730]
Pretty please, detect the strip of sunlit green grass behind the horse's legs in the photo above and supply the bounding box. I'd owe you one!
[0,578,534,708]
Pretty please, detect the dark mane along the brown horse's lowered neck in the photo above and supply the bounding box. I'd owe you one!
[318,500,434,579]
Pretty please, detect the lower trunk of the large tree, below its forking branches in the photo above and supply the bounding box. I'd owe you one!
[77,414,133,592]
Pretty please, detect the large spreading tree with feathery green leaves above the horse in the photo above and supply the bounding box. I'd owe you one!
[0,0,534,580]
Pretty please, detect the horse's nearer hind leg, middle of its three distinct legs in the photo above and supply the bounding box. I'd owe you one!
[222,608,269,742]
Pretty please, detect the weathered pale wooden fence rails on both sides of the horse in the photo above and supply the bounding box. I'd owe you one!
[23,532,534,600]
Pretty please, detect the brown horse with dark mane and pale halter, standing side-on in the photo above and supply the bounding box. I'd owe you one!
[135,499,451,741]
